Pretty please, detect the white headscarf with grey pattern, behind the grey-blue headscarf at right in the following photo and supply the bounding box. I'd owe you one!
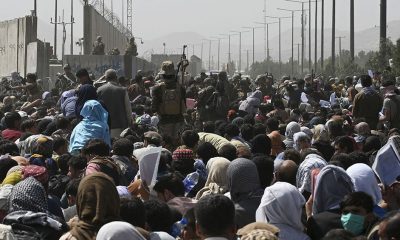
[296,154,328,193]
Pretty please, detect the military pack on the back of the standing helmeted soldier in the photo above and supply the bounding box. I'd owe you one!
[159,83,185,115]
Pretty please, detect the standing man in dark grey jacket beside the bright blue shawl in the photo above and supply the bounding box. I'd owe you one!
[97,69,132,137]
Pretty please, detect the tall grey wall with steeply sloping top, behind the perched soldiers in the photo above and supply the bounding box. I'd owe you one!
[83,5,128,55]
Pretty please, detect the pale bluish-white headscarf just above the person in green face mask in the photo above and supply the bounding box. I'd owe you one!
[346,163,382,204]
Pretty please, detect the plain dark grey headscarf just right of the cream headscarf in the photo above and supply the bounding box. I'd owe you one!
[226,158,261,202]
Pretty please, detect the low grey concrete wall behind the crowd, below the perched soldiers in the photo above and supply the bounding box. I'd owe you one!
[63,55,155,78]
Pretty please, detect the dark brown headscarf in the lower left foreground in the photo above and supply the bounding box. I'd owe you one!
[70,172,120,240]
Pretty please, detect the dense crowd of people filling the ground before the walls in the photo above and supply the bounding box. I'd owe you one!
[0,61,400,240]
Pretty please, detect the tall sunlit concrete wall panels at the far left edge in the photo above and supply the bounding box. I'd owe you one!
[0,16,37,76]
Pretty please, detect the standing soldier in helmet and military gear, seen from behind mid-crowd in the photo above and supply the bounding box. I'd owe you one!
[152,61,186,145]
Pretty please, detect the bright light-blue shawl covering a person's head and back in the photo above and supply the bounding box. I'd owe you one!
[69,100,111,154]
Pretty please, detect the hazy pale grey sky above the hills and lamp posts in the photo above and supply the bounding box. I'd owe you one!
[0,0,400,56]
